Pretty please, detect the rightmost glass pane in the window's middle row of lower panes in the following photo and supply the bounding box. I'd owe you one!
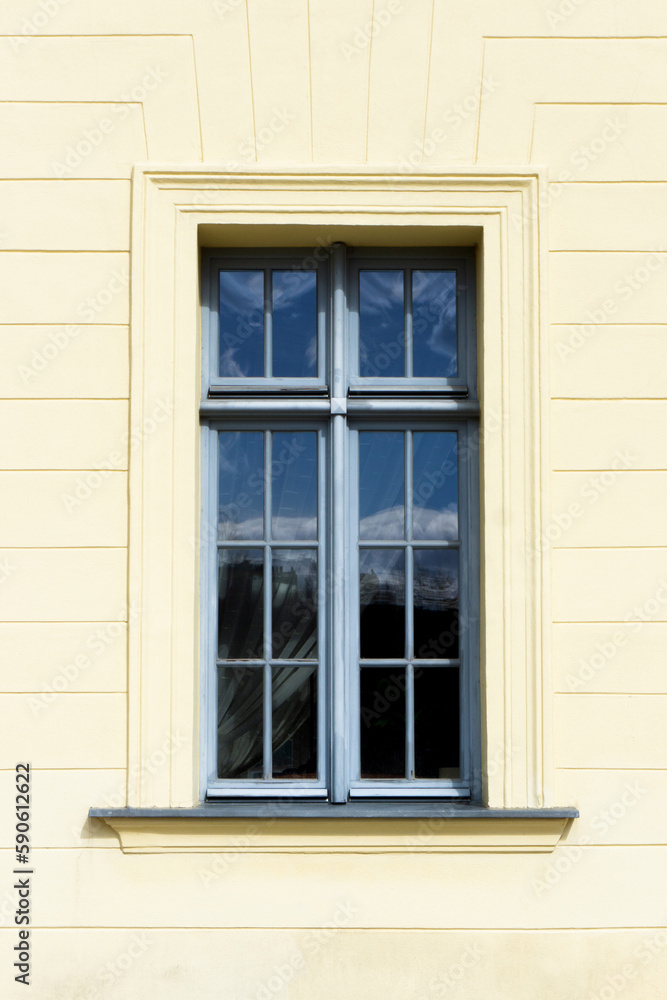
[414,549,459,660]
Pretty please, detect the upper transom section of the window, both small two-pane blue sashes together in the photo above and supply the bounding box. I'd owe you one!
[202,244,477,401]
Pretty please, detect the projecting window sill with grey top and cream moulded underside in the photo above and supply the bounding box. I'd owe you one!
[89,801,579,854]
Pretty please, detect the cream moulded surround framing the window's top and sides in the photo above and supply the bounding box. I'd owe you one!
[122,166,556,828]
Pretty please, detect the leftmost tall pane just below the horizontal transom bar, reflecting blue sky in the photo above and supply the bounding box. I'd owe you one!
[218,431,264,541]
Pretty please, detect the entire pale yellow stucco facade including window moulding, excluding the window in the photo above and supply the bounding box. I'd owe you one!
[0,0,667,1000]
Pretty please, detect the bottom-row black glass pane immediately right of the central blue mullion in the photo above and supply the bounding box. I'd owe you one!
[359,667,405,779]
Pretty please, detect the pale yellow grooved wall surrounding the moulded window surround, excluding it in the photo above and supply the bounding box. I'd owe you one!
[0,0,667,1000]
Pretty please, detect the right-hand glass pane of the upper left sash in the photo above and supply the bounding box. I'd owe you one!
[272,271,317,378]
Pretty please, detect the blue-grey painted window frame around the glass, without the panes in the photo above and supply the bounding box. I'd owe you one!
[200,244,481,803]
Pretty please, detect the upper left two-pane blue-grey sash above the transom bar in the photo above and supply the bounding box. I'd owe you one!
[202,249,329,399]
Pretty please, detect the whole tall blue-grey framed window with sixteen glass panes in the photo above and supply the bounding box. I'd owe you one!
[201,244,480,802]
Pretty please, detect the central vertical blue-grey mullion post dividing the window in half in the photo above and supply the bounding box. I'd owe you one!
[330,244,349,802]
